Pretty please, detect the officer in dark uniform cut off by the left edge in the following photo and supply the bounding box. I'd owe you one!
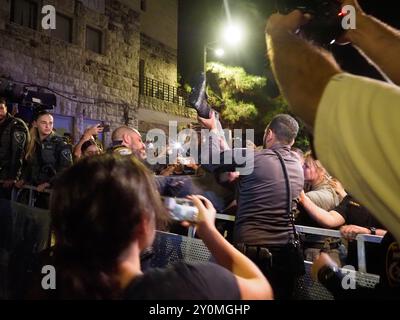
[0,98,29,198]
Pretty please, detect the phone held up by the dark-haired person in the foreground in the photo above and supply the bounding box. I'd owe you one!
[163,197,199,222]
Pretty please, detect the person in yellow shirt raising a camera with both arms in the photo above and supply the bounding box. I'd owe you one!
[266,0,400,291]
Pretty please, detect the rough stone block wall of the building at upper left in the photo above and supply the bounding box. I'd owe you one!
[0,0,185,147]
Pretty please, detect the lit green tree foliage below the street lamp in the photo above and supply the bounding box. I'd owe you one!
[207,62,309,150]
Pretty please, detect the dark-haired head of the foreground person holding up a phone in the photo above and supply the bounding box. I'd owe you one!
[50,154,164,299]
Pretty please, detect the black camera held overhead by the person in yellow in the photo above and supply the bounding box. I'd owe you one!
[276,0,345,46]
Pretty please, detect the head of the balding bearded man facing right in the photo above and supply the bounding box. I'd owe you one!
[111,126,146,160]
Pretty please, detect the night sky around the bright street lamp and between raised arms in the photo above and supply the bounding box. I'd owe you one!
[178,0,400,87]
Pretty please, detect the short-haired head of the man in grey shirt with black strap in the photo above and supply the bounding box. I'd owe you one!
[264,114,299,148]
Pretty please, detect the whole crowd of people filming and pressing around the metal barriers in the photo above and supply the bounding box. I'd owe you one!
[0,0,400,300]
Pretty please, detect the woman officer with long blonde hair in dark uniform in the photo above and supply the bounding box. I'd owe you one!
[17,111,72,206]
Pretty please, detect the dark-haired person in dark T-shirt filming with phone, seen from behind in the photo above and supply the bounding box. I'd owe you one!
[33,154,273,300]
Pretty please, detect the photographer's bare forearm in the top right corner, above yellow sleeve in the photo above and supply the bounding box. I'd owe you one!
[344,0,400,85]
